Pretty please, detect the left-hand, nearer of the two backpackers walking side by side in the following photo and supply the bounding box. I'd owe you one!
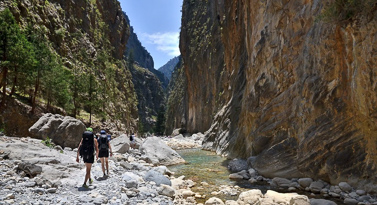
[76,127,98,188]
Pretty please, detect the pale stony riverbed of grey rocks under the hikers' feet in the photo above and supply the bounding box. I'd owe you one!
[0,136,376,205]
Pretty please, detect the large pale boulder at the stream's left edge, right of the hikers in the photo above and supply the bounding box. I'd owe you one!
[140,137,185,166]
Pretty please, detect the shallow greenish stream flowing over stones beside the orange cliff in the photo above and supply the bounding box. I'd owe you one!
[169,149,343,204]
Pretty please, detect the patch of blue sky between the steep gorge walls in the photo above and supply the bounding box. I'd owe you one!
[118,0,183,69]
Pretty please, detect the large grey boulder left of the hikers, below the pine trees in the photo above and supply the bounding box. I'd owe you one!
[29,113,85,148]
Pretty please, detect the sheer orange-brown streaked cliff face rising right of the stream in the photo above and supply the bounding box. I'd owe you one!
[168,0,377,189]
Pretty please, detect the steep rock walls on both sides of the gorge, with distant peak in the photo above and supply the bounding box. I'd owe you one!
[0,0,377,201]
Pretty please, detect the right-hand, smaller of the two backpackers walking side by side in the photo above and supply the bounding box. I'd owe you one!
[98,130,113,177]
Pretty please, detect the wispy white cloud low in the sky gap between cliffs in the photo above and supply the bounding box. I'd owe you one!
[141,32,180,57]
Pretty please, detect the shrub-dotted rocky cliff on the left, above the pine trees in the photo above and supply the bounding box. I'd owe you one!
[0,0,138,133]
